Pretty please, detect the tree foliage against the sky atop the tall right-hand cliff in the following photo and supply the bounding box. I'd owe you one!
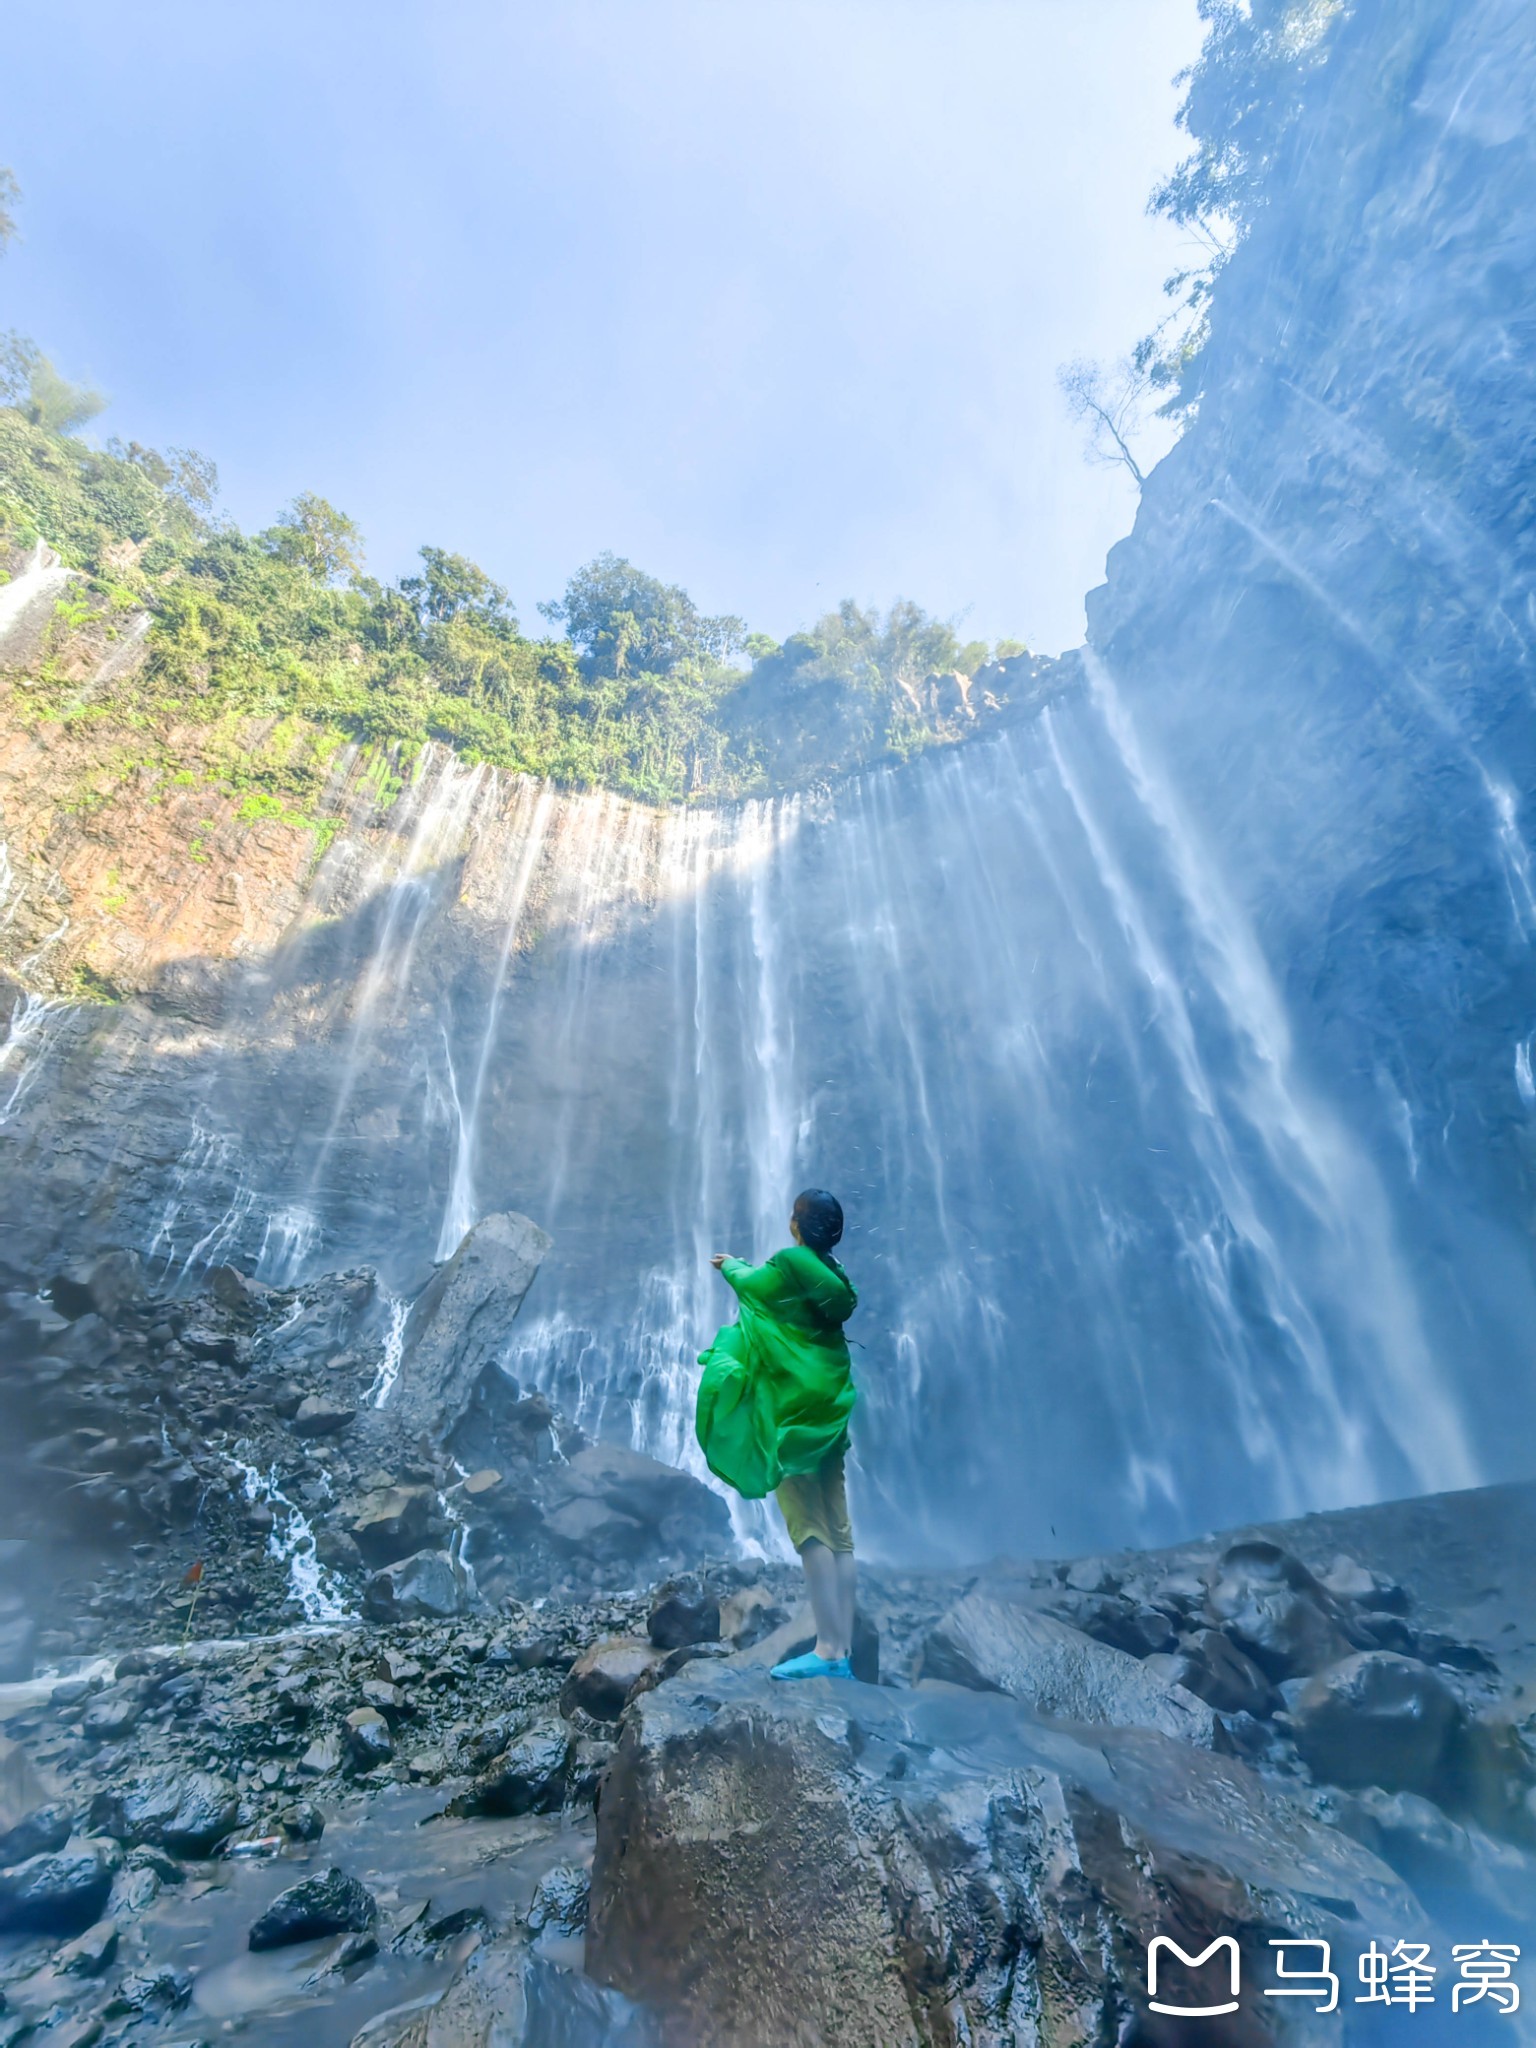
[1133,0,1346,418]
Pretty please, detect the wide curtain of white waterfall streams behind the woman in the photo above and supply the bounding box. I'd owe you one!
[15,696,1490,1559]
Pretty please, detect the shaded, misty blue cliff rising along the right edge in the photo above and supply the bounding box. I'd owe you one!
[1090,0,1536,1470]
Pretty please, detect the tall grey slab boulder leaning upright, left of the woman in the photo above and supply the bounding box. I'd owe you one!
[389,1214,551,1444]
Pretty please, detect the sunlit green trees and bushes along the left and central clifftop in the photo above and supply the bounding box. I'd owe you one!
[0,395,1036,811]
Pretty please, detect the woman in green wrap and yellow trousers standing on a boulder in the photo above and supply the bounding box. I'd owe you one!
[696,1188,858,1677]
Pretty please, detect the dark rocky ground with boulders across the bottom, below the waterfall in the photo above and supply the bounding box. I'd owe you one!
[0,1217,1536,2048]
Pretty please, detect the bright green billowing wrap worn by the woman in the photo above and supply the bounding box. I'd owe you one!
[694,1245,858,1501]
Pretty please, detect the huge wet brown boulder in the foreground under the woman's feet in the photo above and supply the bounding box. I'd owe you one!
[586,1665,1425,2048]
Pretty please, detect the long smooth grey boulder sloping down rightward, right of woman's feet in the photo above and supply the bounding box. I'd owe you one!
[922,1591,1217,1749]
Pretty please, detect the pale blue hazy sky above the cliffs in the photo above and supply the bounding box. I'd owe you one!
[0,0,1200,651]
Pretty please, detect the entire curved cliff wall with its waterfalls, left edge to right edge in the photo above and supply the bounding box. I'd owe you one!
[0,0,1536,1556]
